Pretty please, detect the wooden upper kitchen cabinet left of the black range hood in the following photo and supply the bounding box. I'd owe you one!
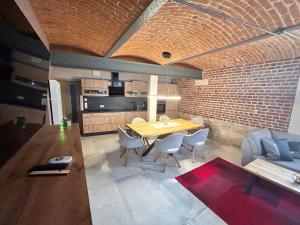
[81,79,109,96]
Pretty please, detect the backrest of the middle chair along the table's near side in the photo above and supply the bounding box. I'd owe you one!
[154,133,184,151]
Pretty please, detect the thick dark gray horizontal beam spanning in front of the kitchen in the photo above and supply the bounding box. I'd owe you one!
[50,51,202,79]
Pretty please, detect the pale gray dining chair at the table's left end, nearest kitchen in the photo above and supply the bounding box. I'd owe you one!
[118,127,145,166]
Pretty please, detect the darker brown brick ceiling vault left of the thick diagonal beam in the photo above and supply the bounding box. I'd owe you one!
[29,0,151,56]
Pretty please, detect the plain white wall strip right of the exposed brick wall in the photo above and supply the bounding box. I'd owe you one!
[289,79,300,135]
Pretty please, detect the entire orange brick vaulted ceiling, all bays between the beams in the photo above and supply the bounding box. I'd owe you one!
[24,0,300,69]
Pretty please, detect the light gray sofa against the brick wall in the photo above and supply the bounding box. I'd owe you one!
[241,129,300,173]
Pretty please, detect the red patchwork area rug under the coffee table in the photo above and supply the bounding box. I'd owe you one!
[176,158,300,225]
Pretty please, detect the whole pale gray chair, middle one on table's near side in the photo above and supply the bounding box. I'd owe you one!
[154,133,184,172]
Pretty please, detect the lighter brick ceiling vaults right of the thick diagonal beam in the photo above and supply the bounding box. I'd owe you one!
[114,0,300,69]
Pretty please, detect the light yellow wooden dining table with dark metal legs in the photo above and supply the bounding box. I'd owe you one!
[126,119,203,156]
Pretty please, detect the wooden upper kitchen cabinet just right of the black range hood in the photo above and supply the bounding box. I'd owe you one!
[125,81,148,97]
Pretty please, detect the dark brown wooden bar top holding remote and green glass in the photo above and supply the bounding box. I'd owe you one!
[0,124,92,225]
